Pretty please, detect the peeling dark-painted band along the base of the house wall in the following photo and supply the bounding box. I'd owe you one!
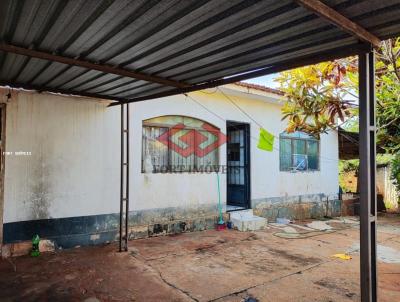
[3,195,341,249]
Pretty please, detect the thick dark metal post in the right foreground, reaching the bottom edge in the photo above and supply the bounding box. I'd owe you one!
[359,52,377,302]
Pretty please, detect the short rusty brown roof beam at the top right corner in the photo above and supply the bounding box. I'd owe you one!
[295,0,381,47]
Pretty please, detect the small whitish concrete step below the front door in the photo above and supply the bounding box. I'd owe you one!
[230,209,267,232]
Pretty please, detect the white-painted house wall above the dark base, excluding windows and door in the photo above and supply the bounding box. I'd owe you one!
[4,86,338,223]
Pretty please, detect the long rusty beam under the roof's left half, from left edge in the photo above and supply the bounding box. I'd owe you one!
[0,43,189,88]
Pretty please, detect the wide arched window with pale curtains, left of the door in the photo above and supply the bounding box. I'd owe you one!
[142,115,220,173]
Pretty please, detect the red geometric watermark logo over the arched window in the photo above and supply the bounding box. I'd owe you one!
[156,123,226,157]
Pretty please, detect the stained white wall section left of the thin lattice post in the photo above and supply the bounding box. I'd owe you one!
[4,92,120,223]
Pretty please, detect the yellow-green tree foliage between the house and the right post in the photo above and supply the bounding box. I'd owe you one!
[276,61,354,137]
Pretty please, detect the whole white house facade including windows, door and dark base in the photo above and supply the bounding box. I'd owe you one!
[0,84,340,248]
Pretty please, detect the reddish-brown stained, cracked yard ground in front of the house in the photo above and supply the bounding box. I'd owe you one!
[0,216,400,302]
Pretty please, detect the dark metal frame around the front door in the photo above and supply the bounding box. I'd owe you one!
[226,120,251,211]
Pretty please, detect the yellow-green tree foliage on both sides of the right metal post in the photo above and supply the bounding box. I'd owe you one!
[276,38,400,154]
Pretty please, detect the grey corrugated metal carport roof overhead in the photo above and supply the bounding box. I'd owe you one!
[0,0,400,100]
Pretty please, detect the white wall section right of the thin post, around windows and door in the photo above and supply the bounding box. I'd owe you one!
[132,87,339,206]
